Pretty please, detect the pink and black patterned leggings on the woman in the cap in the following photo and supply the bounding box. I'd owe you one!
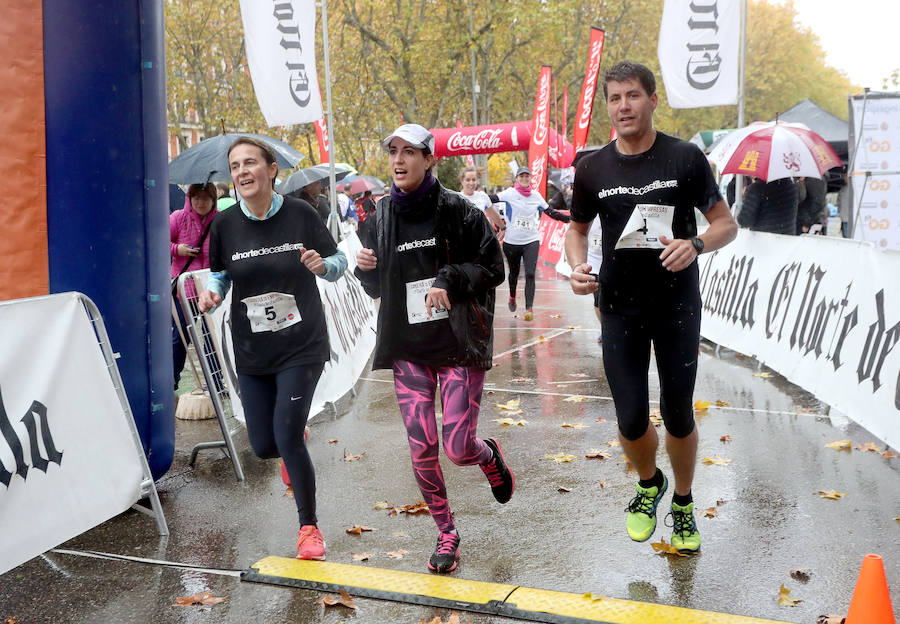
[394,360,493,533]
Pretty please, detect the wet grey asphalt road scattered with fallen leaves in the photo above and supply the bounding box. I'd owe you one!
[0,268,900,624]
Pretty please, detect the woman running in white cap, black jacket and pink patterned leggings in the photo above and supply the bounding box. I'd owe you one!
[355,124,515,572]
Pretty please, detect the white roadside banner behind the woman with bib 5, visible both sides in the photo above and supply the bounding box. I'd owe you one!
[211,227,377,420]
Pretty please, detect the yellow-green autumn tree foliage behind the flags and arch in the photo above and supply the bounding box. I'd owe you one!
[166,0,854,175]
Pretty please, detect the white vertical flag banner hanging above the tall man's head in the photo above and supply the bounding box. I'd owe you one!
[657,0,741,108]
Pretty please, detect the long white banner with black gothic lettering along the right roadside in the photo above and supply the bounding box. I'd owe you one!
[700,229,900,448]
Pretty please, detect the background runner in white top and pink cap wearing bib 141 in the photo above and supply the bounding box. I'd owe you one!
[497,167,569,321]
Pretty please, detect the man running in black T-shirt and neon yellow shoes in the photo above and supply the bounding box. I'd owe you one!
[566,61,737,551]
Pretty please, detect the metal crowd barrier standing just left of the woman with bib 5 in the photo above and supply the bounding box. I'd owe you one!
[178,269,244,481]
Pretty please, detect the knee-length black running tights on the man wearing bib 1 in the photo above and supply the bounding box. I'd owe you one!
[600,306,700,440]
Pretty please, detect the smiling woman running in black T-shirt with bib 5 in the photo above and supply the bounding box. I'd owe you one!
[198,137,347,559]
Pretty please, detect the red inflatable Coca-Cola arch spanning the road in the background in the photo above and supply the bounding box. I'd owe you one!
[431,121,574,167]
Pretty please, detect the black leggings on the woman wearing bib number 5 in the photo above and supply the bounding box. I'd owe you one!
[238,364,325,526]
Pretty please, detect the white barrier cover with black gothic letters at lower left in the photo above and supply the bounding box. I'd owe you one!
[0,294,143,574]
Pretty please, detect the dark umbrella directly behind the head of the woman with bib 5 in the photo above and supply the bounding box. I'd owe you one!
[169,134,303,184]
